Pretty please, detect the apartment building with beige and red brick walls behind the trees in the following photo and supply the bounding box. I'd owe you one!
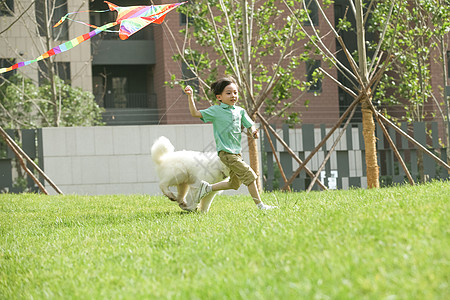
[0,0,449,134]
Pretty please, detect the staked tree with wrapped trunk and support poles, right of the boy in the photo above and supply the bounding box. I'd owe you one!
[285,0,450,188]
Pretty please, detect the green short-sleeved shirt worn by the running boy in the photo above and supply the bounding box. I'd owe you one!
[200,103,254,154]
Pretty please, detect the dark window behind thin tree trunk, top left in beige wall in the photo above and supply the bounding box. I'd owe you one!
[34,0,69,41]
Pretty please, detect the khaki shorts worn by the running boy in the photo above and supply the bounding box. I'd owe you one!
[219,151,258,190]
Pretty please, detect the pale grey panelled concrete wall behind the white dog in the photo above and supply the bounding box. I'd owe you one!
[42,124,256,195]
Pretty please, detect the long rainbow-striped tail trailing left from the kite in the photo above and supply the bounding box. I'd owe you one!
[0,22,117,74]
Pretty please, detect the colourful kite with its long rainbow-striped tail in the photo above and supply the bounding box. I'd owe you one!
[0,1,186,74]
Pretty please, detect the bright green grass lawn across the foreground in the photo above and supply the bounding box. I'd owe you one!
[0,182,450,299]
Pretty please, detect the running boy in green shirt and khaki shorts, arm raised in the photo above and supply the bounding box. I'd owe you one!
[184,77,276,210]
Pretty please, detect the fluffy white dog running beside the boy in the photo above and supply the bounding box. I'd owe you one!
[151,136,229,212]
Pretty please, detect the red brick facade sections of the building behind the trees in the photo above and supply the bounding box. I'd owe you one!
[137,0,449,136]
